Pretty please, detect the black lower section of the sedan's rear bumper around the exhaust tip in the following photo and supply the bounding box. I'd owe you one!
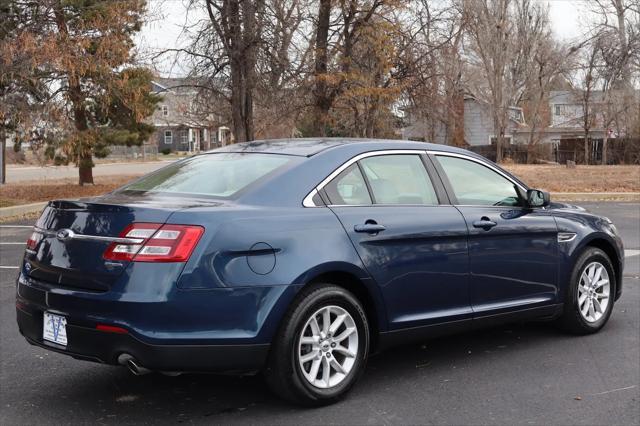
[16,307,270,372]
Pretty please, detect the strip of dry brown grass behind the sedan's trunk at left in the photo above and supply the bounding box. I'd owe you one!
[0,176,136,207]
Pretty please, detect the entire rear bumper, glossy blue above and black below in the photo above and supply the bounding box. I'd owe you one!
[16,275,296,372]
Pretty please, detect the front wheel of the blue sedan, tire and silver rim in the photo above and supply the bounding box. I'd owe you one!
[558,247,617,334]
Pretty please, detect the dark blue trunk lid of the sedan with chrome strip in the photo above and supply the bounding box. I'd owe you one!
[25,196,215,291]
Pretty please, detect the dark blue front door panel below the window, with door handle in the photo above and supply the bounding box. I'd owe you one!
[458,206,558,313]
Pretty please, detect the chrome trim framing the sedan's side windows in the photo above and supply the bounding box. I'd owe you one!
[302,149,527,209]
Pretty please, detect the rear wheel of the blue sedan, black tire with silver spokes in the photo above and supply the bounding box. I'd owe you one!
[264,284,370,406]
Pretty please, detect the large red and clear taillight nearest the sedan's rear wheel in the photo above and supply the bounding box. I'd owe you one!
[103,223,204,262]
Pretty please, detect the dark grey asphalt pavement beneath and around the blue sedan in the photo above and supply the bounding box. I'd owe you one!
[0,202,640,425]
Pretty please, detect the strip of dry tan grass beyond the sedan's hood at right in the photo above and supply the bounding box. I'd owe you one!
[504,164,640,192]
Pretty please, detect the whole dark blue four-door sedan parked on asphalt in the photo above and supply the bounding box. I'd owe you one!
[16,139,624,405]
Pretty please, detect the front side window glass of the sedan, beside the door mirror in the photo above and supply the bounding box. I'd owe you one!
[436,155,522,206]
